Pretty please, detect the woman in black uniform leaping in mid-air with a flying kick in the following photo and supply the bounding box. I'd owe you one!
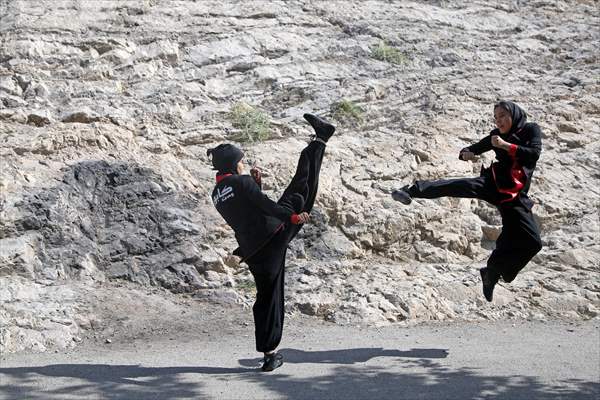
[392,101,542,301]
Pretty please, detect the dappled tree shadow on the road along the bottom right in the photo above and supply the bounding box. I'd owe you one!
[247,359,600,400]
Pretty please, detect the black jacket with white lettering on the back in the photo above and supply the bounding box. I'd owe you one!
[212,175,293,261]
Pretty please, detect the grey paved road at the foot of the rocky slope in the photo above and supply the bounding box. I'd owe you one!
[0,319,600,400]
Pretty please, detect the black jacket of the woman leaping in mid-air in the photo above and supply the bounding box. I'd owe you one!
[459,123,542,194]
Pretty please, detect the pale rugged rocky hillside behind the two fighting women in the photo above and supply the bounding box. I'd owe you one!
[0,0,600,351]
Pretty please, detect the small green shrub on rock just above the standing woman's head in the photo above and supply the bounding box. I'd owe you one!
[229,102,271,142]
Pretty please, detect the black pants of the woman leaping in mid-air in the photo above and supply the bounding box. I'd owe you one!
[408,174,542,282]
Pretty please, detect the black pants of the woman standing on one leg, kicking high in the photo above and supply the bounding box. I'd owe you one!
[247,141,325,352]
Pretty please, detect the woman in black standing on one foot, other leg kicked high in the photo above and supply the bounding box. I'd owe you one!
[207,114,335,371]
